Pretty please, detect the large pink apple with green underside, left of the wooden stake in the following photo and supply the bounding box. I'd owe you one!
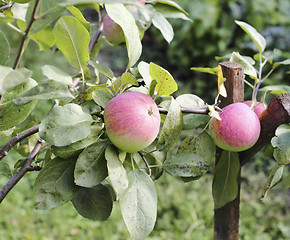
[104,92,160,153]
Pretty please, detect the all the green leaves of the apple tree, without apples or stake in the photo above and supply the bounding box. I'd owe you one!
[0,0,289,239]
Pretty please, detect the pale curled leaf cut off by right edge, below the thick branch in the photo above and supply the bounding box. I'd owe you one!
[271,124,290,165]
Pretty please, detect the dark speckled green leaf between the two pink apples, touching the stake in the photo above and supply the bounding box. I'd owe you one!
[177,131,215,164]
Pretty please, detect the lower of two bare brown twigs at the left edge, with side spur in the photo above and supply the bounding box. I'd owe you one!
[0,139,44,203]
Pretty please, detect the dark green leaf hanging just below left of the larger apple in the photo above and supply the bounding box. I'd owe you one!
[74,141,108,188]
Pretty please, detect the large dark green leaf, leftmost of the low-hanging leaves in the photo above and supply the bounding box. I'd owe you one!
[34,157,78,209]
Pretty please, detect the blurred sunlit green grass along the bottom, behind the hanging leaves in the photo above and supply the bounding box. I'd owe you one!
[0,154,290,240]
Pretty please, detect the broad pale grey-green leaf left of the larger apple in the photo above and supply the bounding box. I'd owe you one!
[39,103,93,146]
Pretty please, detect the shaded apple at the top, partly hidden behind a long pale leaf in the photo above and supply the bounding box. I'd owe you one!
[102,14,126,45]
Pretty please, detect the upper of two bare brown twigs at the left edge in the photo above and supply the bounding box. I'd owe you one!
[0,125,39,161]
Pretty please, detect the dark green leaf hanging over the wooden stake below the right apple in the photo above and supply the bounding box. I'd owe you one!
[212,150,240,209]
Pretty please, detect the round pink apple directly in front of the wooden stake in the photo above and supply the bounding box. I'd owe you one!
[209,103,261,152]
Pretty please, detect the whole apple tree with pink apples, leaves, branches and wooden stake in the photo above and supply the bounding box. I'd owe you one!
[0,0,290,239]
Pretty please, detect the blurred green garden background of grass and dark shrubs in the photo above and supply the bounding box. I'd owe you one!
[0,0,290,240]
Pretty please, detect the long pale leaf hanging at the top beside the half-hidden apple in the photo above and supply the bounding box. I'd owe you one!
[105,3,142,69]
